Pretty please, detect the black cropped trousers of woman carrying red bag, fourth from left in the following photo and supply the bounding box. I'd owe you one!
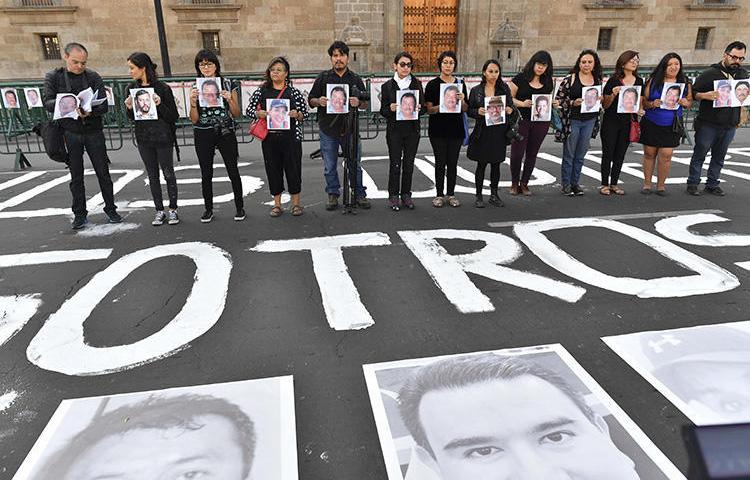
[261,132,302,196]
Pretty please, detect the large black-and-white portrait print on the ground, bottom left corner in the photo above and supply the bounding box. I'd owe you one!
[13,376,298,480]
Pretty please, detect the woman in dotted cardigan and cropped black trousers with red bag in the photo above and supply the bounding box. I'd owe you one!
[245,57,307,217]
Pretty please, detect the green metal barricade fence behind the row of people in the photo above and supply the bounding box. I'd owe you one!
[0,72,736,155]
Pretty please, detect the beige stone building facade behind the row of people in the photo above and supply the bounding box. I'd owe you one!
[0,0,750,80]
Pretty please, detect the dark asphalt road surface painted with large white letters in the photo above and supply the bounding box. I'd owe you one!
[0,130,750,480]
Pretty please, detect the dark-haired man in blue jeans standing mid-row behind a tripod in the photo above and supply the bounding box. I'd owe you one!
[308,40,370,210]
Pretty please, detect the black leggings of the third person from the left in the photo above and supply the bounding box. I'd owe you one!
[193,128,244,210]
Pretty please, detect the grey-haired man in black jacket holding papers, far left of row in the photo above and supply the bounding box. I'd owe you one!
[44,43,122,229]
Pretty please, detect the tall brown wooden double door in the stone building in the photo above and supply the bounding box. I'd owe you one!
[403,0,459,72]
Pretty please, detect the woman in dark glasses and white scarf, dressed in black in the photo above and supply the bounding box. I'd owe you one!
[380,52,424,211]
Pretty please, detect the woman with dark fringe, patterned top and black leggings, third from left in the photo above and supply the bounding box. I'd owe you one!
[190,50,245,223]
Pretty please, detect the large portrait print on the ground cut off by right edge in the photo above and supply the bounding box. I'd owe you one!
[602,322,750,425]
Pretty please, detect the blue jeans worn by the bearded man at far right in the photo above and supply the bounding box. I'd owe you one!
[688,123,736,188]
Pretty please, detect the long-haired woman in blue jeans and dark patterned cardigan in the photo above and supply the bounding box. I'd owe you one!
[557,49,602,196]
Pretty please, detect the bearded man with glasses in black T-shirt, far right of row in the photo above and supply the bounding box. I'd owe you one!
[687,41,748,197]
